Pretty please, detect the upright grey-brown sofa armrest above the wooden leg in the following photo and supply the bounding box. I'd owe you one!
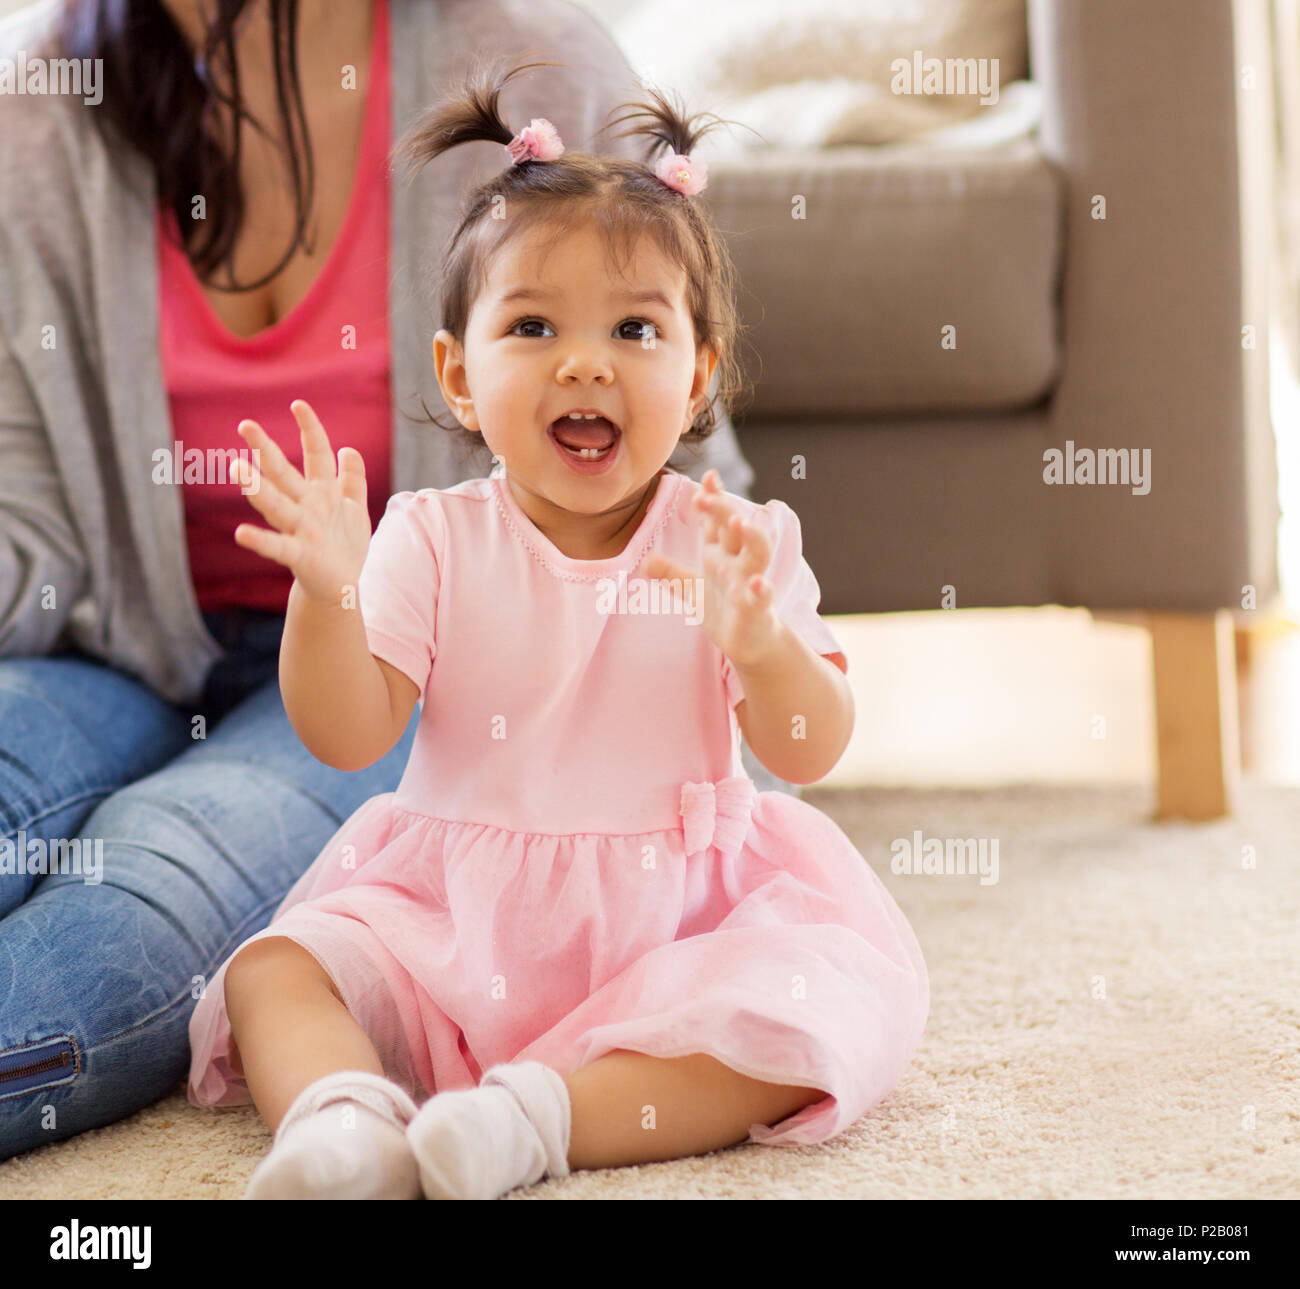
[1028,0,1278,611]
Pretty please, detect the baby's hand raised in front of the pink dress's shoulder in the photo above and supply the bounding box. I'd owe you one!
[642,470,781,667]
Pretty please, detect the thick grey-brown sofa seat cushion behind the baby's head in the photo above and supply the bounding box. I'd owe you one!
[701,139,1062,417]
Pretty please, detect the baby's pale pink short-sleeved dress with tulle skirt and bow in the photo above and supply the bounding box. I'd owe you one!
[189,468,930,1145]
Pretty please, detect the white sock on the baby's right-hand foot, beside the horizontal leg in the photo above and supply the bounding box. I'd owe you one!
[407,1060,571,1199]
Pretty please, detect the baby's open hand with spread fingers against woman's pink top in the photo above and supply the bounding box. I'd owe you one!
[235,399,371,604]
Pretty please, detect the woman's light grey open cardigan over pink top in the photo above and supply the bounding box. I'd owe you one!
[0,0,753,704]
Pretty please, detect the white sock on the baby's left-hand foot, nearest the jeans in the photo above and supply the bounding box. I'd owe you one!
[244,1069,420,1199]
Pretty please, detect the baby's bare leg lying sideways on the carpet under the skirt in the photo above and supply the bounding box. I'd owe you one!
[564,1049,826,1168]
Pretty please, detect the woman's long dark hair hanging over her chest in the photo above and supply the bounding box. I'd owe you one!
[55,0,316,291]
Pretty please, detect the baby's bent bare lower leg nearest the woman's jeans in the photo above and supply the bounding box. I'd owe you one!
[225,936,384,1132]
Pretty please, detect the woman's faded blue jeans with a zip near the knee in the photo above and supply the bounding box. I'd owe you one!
[0,609,420,1159]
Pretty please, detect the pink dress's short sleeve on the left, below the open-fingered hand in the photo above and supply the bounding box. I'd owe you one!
[356,489,443,699]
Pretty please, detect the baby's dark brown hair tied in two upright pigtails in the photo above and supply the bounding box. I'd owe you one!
[394,60,746,457]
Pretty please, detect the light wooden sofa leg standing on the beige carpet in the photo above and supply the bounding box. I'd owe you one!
[1145,609,1242,819]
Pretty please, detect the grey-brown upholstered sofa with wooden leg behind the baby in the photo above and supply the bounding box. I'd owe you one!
[706,0,1278,817]
